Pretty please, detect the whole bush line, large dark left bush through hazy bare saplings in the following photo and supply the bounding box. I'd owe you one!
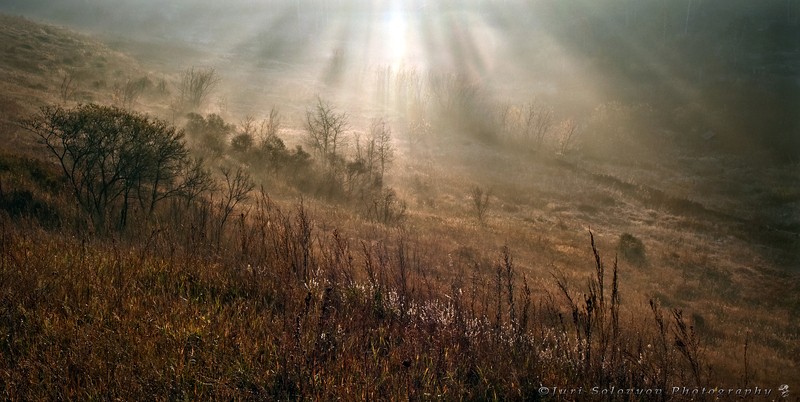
[14,89,412,230]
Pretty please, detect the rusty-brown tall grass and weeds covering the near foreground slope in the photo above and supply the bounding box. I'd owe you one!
[0,187,706,400]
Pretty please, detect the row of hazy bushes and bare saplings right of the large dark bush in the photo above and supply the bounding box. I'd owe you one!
[184,99,405,224]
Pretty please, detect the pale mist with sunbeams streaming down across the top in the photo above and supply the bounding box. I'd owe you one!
[1,0,800,160]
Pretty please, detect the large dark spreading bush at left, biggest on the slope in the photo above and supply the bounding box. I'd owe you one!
[21,104,209,230]
